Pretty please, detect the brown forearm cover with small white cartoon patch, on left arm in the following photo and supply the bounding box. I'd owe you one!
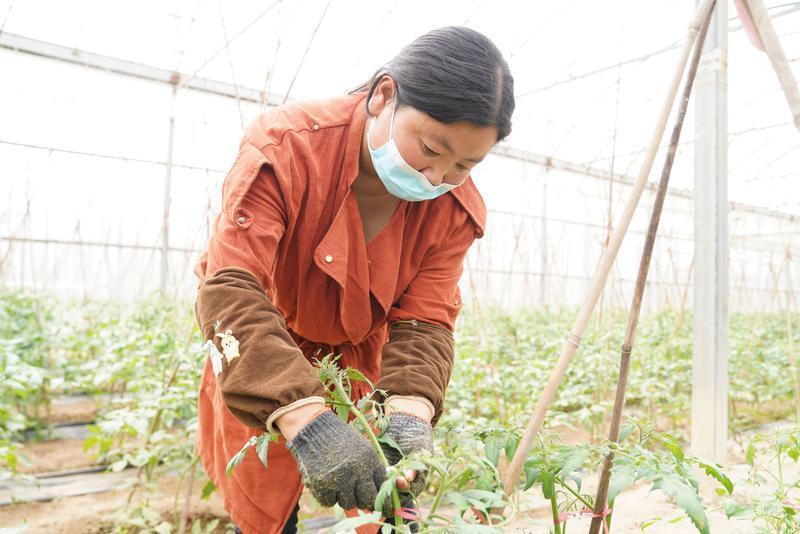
[196,267,325,430]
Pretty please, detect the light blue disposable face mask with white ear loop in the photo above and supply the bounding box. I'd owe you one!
[367,99,466,202]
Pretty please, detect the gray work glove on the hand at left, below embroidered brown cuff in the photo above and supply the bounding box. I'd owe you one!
[286,411,386,510]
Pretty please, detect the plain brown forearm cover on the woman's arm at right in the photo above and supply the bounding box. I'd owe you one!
[376,321,453,426]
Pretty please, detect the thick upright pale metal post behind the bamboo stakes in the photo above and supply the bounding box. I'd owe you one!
[691,2,728,463]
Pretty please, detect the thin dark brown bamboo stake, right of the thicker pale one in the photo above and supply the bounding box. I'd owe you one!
[589,2,713,534]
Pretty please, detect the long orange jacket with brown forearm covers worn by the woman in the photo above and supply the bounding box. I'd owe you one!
[195,92,486,532]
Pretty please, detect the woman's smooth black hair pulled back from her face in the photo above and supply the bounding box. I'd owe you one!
[355,26,515,141]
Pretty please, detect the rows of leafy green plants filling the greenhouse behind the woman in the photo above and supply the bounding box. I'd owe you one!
[0,289,800,531]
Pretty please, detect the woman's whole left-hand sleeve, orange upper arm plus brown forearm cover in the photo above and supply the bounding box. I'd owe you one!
[195,166,324,429]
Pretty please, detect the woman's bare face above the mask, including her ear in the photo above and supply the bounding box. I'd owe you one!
[368,76,497,185]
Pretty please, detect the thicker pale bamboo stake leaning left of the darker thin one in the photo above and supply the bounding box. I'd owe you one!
[503,0,714,504]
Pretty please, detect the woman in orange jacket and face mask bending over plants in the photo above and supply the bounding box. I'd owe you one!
[195,27,514,533]
